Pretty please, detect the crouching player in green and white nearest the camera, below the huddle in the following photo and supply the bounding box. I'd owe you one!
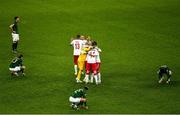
[69,87,88,110]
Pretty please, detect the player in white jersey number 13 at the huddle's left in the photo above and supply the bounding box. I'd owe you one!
[71,35,83,76]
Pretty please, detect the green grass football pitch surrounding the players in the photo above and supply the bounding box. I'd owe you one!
[0,0,180,114]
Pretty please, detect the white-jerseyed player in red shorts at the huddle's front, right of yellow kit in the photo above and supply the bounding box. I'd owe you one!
[84,47,99,84]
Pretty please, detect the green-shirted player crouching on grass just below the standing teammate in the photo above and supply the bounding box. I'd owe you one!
[9,54,25,76]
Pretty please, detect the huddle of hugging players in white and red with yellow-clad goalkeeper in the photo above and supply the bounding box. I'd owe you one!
[70,35,101,85]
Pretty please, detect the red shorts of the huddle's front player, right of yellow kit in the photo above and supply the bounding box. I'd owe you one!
[86,63,97,74]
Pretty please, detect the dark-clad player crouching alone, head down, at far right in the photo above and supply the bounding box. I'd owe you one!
[157,65,172,83]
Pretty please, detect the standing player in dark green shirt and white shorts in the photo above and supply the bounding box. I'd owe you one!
[9,16,20,53]
